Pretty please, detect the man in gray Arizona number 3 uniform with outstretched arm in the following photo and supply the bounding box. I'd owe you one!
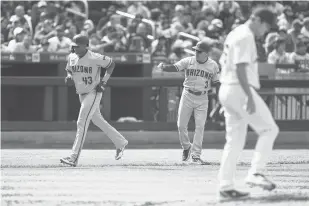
[158,42,219,165]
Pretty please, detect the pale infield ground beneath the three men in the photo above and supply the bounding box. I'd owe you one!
[1,149,309,206]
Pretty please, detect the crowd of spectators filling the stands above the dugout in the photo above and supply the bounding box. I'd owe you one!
[1,0,309,68]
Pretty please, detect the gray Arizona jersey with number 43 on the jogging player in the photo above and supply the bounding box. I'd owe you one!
[66,51,112,94]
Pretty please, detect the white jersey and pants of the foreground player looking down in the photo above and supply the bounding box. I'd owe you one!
[219,25,279,190]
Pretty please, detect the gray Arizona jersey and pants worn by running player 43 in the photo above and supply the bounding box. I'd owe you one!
[66,51,127,161]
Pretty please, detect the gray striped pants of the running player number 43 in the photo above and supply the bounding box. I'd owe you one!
[72,91,128,161]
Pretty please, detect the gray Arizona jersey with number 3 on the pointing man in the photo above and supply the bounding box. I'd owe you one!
[174,56,220,92]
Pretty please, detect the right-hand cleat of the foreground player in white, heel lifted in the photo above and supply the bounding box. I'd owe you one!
[245,173,276,191]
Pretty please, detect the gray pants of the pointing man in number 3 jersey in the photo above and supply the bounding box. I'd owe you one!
[177,89,208,157]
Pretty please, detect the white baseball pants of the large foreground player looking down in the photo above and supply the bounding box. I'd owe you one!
[218,84,279,190]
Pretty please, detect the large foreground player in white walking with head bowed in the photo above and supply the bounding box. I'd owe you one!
[218,7,279,201]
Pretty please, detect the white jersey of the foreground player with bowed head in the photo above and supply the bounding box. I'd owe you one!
[219,24,260,89]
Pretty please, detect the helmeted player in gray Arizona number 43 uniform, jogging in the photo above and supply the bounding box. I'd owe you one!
[60,34,128,166]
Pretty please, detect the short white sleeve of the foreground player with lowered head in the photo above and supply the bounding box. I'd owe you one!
[232,38,253,64]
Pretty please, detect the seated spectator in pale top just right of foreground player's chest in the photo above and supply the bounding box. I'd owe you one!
[267,37,289,64]
